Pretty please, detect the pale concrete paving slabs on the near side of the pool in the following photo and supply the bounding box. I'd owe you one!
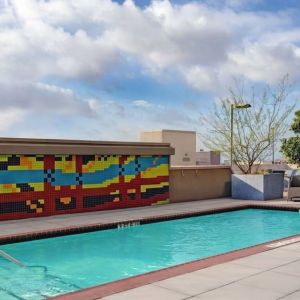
[102,243,300,300]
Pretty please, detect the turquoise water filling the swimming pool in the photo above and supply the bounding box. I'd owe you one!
[0,209,300,300]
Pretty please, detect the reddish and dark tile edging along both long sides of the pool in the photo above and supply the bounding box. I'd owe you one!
[0,203,300,300]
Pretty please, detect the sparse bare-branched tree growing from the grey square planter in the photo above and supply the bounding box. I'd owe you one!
[204,76,295,174]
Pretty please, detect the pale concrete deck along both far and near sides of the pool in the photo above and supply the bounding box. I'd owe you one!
[0,198,300,300]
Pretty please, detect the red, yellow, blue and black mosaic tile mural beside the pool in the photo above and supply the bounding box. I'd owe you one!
[0,155,169,220]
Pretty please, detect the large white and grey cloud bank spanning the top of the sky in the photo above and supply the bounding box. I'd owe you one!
[0,0,300,90]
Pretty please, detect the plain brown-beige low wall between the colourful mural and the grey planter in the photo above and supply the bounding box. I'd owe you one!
[170,166,231,202]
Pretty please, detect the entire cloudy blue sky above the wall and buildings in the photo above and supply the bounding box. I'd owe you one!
[0,0,300,146]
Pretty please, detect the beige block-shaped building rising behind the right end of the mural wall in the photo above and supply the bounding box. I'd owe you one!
[140,129,196,166]
